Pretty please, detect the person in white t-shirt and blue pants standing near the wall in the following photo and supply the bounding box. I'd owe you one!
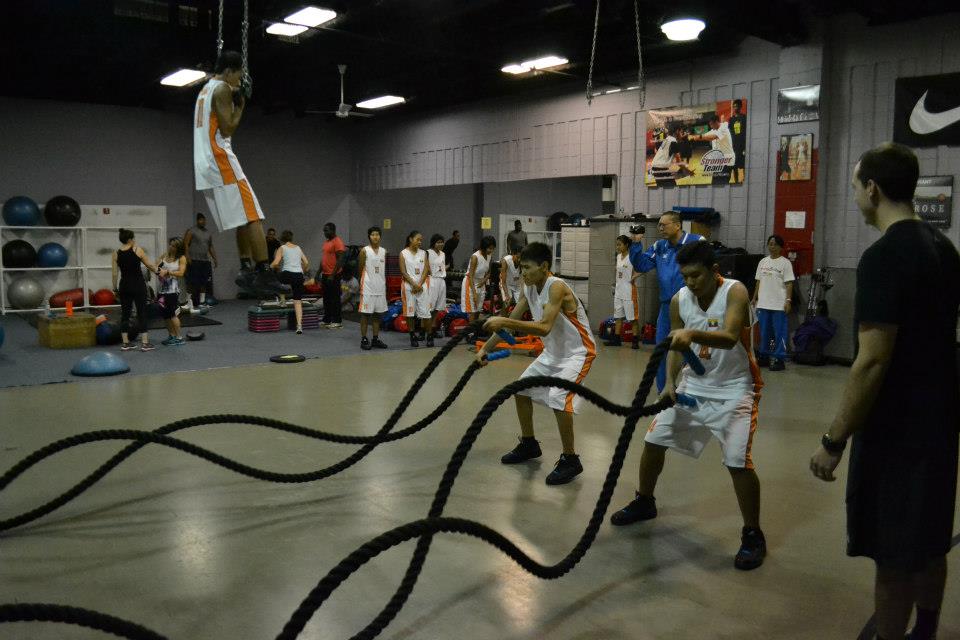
[753,234,796,371]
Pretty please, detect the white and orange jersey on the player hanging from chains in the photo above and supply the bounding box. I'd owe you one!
[193,80,244,189]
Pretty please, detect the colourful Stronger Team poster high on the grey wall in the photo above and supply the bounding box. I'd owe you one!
[645,98,747,187]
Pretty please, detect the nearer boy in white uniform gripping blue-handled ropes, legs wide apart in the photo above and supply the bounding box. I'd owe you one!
[610,242,767,570]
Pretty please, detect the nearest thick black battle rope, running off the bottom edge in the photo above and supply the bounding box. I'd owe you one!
[0,340,673,640]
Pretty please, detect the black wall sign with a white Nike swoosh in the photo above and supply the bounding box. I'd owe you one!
[893,73,960,147]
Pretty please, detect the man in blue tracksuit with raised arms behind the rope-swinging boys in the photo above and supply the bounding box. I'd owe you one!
[630,211,703,391]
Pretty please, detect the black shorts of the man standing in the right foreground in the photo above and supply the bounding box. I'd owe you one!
[847,430,958,571]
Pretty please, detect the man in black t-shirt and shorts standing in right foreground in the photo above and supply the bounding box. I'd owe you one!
[810,144,960,640]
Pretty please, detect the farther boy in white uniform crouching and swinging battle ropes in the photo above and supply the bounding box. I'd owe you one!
[476,242,597,485]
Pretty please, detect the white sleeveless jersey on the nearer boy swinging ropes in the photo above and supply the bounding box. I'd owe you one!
[678,278,763,400]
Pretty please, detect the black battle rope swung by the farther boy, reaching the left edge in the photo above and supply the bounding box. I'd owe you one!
[0,332,479,531]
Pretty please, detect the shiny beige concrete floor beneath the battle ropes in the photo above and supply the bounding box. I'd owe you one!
[0,349,960,640]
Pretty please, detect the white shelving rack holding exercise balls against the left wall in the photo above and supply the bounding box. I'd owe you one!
[0,225,165,315]
